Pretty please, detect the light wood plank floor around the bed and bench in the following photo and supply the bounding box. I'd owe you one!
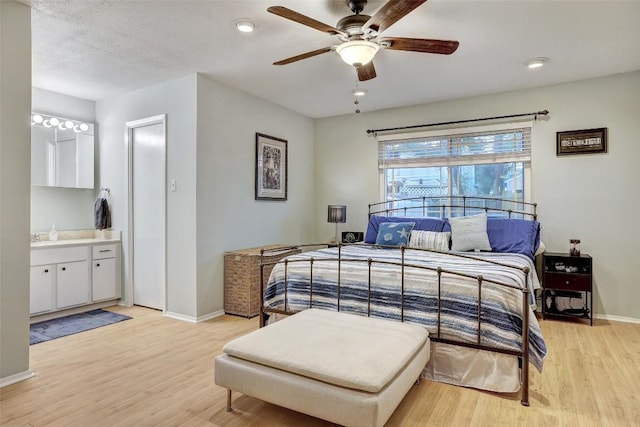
[0,307,640,427]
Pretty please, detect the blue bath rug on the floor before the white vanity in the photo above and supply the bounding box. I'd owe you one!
[29,309,131,345]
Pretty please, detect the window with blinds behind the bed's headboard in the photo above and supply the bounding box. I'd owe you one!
[378,124,531,216]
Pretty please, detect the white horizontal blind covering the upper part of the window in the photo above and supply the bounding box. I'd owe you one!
[378,123,531,169]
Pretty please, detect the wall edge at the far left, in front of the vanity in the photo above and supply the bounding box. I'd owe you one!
[0,1,31,386]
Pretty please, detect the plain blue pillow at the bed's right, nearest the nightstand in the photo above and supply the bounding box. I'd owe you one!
[487,218,540,259]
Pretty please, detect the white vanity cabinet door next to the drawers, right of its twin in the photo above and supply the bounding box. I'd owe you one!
[56,261,91,308]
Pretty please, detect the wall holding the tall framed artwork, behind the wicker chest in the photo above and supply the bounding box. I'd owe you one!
[197,76,315,316]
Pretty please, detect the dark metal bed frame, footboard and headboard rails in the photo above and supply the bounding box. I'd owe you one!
[260,196,537,406]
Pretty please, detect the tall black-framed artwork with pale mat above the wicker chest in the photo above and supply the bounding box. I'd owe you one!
[256,133,289,200]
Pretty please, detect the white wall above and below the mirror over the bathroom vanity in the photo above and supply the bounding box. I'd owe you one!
[31,88,99,233]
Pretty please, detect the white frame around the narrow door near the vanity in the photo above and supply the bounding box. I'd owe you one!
[124,114,167,313]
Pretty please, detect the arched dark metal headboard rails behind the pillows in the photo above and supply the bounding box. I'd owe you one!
[369,196,538,221]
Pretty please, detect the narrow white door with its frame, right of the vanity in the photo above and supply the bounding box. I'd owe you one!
[125,114,166,311]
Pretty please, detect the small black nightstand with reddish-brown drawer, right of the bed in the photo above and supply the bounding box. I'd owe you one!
[542,252,593,326]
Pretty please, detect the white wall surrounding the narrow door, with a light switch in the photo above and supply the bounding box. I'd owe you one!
[96,74,196,317]
